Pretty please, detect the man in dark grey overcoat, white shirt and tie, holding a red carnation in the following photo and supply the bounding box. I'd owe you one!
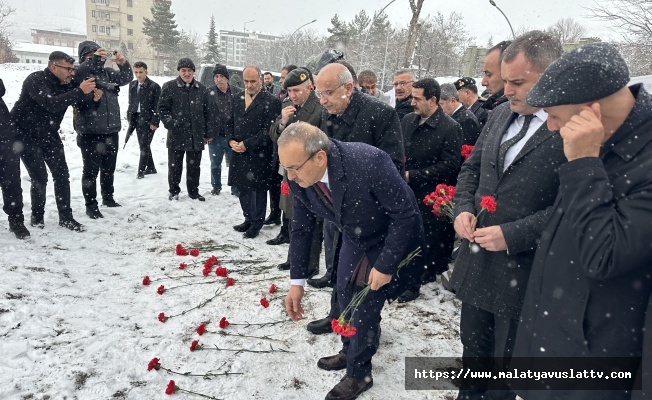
[450,31,564,399]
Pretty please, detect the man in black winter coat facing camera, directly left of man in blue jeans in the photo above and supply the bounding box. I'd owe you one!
[158,58,217,201]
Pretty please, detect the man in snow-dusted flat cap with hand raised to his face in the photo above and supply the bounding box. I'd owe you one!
[514,43,652,400]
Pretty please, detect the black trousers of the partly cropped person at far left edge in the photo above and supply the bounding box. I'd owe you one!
[0,139,25,223]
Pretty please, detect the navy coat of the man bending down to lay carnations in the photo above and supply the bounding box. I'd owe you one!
[290,140,423,300]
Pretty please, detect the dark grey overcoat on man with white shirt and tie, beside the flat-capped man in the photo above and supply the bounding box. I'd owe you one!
[451,103,566,319]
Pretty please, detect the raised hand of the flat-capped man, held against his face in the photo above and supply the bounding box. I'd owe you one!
[559,103,604,161]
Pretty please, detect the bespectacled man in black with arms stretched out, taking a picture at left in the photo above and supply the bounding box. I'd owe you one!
[11,51,98,231]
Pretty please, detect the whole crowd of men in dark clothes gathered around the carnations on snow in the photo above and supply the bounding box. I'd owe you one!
[0,31,652,400]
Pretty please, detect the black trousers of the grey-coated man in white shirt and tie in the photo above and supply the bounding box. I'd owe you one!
[457,303,518,400]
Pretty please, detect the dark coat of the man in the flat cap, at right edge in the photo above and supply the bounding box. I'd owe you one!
[514,85,652,399]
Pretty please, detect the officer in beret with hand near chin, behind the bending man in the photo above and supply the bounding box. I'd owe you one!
[267,68,324,277]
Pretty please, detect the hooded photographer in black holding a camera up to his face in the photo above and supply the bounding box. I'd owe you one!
[75,41,133,219]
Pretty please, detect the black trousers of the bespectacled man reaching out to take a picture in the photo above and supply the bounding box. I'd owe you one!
[20,135,72,220]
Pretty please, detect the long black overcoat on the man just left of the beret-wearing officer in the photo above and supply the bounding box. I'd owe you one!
[227,90,281,190]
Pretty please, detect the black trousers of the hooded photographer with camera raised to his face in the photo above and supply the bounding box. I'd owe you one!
[77,132,119,207]
